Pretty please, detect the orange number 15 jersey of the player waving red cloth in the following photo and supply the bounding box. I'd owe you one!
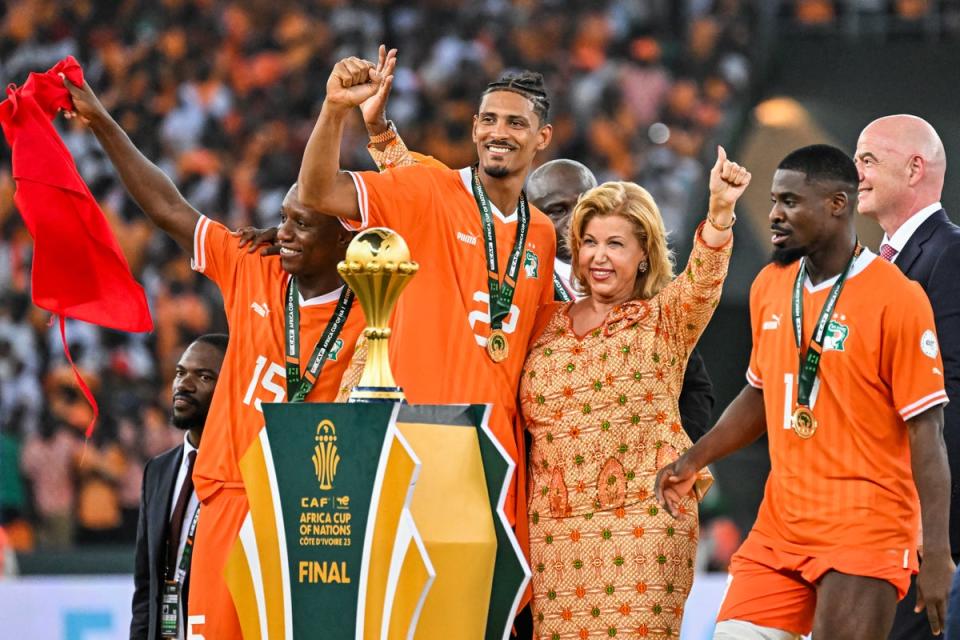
[193,216,366,500]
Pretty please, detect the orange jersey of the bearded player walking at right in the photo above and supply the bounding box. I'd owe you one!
[747,250,947,568]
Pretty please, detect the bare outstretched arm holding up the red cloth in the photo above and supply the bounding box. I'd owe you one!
[63,78,200,253]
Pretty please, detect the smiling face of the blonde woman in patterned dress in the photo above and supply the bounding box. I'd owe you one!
[576,214,647,304]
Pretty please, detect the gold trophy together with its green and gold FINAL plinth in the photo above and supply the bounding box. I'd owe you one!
[232,228,530,640]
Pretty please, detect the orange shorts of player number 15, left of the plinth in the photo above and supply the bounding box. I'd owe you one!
[187,489,249,640]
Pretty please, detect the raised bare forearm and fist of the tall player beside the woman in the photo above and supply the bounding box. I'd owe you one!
[299,53,396,220]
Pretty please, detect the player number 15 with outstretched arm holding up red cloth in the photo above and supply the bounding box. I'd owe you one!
[64,80,366,640]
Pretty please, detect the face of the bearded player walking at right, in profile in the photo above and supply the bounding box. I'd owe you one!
[769,169,831,265]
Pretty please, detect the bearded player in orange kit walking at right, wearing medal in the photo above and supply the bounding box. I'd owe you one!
[655,145,953,640]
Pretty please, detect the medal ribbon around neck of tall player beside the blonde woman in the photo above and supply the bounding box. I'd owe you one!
[470,165,530,331]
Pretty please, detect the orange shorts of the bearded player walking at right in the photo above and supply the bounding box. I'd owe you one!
[717,533,913,635]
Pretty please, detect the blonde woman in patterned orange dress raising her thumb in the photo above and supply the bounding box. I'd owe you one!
[520,149,750,640]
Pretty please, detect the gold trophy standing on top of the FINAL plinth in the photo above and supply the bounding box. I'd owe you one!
[337,227,420,402]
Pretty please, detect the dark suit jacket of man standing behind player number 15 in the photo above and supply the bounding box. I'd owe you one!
[130,444,183,640]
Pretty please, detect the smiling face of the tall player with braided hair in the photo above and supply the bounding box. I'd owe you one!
[473,91,553,178]
